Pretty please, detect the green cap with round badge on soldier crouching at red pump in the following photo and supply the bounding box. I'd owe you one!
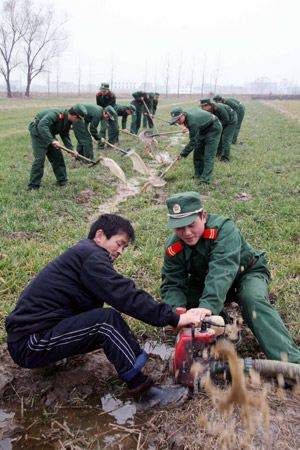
[167,191,203,229]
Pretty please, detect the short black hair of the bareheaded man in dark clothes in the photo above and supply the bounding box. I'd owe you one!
[88,214,135,242]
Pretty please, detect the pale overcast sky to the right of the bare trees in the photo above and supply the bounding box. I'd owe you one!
[45,0,300,89]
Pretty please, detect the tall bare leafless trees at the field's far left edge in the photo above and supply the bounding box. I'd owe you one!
[0,0,68,98]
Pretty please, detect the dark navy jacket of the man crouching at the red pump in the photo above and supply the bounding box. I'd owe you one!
[6,239,179,342]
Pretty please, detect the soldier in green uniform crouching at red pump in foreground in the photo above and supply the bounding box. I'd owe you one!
[161,192,300,363]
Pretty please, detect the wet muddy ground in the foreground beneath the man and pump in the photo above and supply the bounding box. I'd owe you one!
[0,328,300,450]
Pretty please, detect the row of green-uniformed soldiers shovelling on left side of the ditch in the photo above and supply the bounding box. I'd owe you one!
[29,83,159,191]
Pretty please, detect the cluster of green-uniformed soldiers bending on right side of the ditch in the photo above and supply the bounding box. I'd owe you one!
[170,95,245,185]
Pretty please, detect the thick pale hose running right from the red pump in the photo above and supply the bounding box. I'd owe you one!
[244,358,300,379]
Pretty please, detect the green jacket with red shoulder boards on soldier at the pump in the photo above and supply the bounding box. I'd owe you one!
[161,214,268,314]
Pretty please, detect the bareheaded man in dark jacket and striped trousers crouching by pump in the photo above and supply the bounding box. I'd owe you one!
[6,214,200,405]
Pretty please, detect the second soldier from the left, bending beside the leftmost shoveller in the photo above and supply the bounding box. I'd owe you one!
[73,104,119,161]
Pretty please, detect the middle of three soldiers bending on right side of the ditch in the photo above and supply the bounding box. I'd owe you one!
[199,98,237,162]
